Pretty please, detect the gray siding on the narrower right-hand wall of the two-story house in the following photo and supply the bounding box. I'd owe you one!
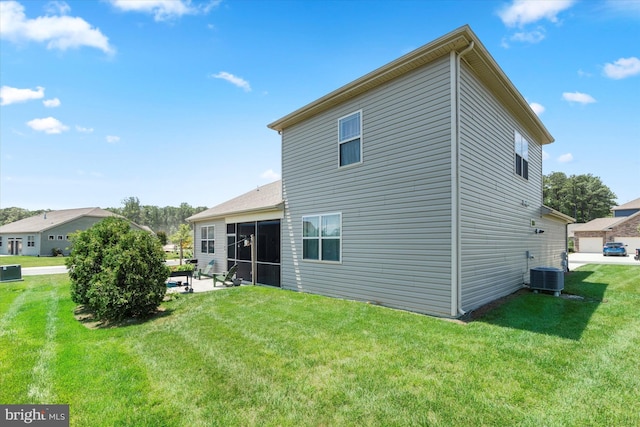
[460,64,544,310]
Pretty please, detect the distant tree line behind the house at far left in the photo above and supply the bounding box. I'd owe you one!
[0,197,207,235]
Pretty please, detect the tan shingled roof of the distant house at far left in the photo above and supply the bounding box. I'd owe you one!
[0,208,119,233]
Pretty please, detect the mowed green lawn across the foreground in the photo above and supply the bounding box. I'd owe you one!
[0,265,640,427]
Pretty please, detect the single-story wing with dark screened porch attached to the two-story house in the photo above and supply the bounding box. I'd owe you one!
[187,181,283,286]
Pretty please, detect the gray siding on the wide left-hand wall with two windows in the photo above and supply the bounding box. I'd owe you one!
[282,57,451,316]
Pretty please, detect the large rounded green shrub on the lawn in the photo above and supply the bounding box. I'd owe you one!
[66,217,169,320]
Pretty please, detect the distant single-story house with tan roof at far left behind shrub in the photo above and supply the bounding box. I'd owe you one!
[0,208,141,256]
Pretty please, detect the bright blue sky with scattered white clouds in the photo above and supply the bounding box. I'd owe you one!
[0,0,640,209]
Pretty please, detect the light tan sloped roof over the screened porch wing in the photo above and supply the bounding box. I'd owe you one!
[187,180,284,222]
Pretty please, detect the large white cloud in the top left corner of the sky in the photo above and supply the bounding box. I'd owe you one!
[0,1,115,54]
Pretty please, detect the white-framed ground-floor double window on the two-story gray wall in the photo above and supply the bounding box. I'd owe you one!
[302,213,342,261]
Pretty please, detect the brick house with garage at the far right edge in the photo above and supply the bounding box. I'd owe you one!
[574,199,640,253]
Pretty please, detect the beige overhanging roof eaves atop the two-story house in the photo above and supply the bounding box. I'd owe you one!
[268,25,554,144]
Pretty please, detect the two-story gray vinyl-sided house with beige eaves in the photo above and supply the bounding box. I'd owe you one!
[264,26,574,317]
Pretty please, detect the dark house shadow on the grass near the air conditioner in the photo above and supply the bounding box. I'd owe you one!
[473,271,607,341]
